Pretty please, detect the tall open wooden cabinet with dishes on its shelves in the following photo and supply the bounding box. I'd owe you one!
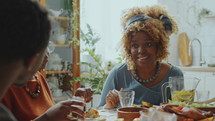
[39,0,80,100]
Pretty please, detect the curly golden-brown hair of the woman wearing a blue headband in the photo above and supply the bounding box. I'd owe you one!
[121,5,178,70]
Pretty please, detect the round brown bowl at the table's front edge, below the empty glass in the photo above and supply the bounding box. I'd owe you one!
[117,107,147,121]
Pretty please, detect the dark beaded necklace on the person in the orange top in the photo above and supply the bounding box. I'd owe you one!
[24,76,41,98]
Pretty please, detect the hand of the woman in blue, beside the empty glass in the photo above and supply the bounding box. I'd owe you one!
[104,88,124,109]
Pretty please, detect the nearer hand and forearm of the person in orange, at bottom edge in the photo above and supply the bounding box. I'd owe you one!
[33,97,85,121]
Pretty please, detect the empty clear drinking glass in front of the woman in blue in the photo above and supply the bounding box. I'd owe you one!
[118,90,135,107]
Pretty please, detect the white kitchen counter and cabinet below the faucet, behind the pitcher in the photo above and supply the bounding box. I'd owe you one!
[182,68,215,98]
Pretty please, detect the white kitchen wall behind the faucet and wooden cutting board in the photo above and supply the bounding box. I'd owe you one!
[158,0,215,66]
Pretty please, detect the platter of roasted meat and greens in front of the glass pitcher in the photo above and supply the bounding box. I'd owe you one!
[139,101,215,121]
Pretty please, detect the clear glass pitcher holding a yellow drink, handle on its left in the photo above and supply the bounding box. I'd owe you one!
[161,76,200,103]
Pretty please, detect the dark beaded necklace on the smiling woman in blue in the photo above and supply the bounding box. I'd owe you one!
[134,62,161,83]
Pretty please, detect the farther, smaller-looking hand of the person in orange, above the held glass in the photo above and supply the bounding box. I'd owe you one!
[75,88,93,103]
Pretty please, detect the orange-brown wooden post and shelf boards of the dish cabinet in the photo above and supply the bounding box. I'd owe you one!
[39,0,80,77]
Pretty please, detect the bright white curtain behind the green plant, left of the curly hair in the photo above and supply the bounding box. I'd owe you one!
[80,0,157,62]
